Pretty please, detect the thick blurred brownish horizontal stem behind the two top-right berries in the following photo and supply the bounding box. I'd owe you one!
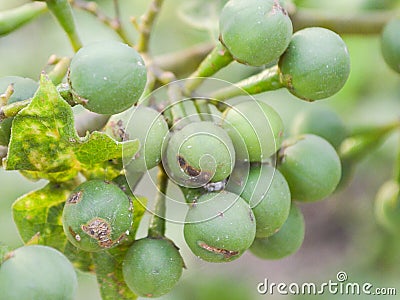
[291,8,398,34]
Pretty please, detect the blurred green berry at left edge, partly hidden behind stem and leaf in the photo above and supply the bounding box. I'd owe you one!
[0,76,39,146]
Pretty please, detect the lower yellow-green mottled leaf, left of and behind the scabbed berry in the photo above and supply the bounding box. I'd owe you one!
[12,183,93,271]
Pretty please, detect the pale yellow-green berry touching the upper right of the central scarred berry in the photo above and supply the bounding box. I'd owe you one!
[222,101,283,162]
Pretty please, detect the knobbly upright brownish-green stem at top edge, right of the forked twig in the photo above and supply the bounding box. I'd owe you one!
[137,0,164,52]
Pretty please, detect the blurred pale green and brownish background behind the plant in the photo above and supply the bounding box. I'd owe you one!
[0,0,400,300]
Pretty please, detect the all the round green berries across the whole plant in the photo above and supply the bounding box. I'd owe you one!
[0,0,400,299]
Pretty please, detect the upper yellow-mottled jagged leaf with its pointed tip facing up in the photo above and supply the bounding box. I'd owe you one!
[4,75,140,182]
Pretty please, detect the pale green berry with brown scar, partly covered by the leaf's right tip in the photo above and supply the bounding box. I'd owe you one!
[106,106,168,172]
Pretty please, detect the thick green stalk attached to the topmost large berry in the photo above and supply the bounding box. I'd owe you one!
[184,43,233,95]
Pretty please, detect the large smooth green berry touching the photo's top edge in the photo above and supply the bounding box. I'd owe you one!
[219,0,293,66]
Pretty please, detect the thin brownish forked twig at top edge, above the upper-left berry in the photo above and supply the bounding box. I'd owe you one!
[70,0,132,46]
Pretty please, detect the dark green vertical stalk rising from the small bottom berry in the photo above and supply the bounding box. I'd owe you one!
[148,166,168,238]
